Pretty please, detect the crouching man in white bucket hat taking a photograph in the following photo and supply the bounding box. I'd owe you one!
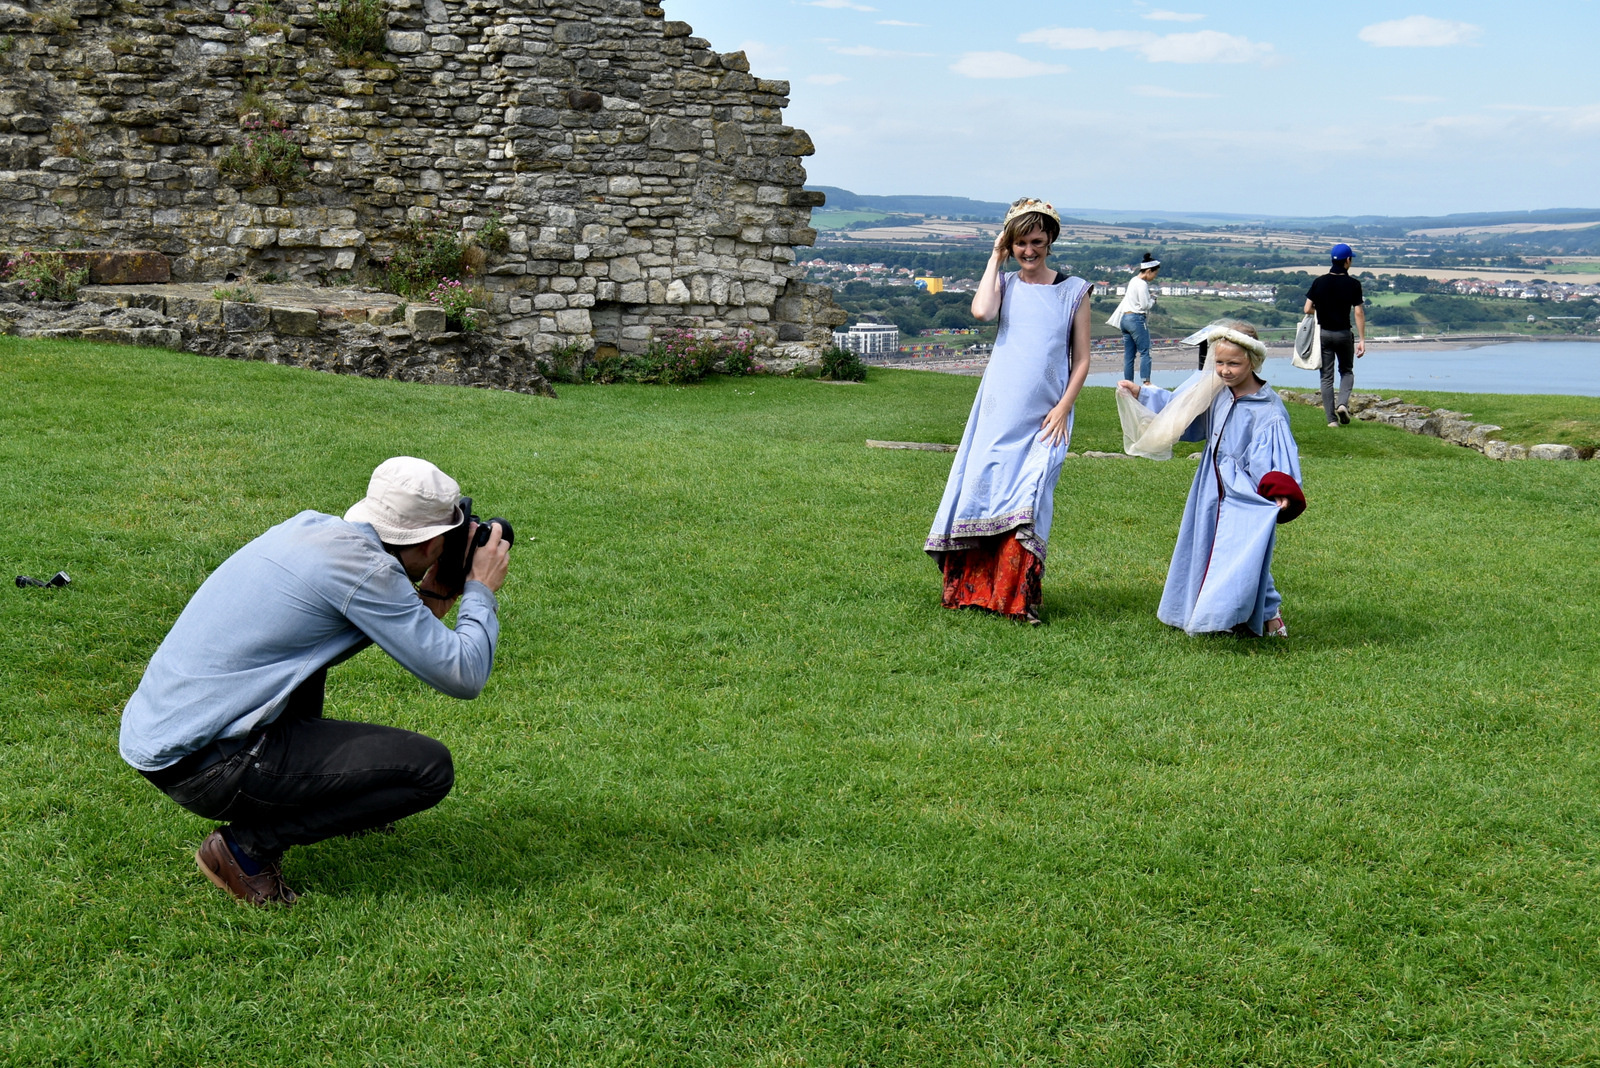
[120,456,512,905]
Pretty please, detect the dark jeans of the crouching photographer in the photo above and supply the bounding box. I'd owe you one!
[146,668,456,862]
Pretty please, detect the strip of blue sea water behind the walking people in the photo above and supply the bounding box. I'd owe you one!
[1088,341,1600,397]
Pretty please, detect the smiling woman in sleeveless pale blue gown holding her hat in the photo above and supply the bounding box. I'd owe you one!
[923,198,1090,624]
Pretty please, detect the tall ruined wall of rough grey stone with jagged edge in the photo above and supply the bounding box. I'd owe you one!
[0,0,845,360]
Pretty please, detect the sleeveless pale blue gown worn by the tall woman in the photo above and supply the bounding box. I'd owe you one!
[923,272,1088,561]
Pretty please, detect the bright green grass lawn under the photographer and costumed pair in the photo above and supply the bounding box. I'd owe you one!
[0,337,1600,1066]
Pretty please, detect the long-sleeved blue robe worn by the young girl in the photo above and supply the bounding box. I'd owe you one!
[1139,384,1301,635]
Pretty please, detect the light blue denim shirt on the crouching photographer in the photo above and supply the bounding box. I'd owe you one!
[118,512,499,771]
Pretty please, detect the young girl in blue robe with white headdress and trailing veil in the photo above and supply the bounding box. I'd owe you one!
[1118,321,1306,638]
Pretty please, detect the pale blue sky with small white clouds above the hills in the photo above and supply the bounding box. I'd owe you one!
[664,0,1600,216]
